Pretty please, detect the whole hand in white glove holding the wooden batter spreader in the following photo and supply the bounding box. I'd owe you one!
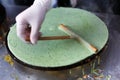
[16,0,51,44]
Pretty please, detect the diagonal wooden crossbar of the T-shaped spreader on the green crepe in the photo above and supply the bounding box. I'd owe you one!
[59,24,97,53]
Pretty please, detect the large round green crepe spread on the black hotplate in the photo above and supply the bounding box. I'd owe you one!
[7,8,108,67]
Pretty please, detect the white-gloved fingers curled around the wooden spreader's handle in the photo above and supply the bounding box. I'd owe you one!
[16,16,40,44]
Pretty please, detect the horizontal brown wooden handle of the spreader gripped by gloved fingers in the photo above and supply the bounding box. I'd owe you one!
[25,36,71,41]
